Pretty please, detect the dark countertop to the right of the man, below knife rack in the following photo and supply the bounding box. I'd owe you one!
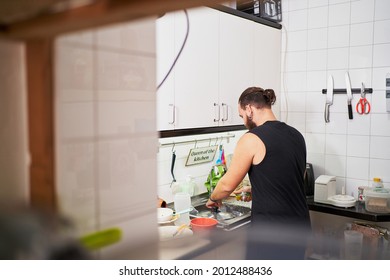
[307,197,390,222]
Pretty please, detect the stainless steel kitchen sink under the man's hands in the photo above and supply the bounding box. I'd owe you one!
[190,203,251,231]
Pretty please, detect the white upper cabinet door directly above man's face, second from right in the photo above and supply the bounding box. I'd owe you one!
[218,13,254,125]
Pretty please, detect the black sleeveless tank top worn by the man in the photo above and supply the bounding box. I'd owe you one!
[248,121,310,226]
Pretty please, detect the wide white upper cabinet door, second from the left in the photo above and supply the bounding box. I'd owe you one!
[174,7,219,128]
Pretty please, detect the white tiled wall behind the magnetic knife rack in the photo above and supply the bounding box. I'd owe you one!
[282,0,390,197]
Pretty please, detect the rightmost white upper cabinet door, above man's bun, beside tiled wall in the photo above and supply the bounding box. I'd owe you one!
[252,22,282,118]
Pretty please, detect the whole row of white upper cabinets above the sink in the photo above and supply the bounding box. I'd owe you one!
[156,7,281,131]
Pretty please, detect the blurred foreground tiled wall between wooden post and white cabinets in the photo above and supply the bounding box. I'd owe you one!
[55,19,158,259]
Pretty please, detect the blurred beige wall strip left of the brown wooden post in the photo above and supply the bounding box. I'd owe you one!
[0,41,29,204]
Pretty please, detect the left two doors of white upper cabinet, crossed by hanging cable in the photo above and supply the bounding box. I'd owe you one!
[156,7,219,130]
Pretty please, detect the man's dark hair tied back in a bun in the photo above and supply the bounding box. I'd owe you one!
[238,87,276,109]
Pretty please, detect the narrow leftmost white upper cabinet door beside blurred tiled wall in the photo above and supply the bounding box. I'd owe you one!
[156,13,176,130]
